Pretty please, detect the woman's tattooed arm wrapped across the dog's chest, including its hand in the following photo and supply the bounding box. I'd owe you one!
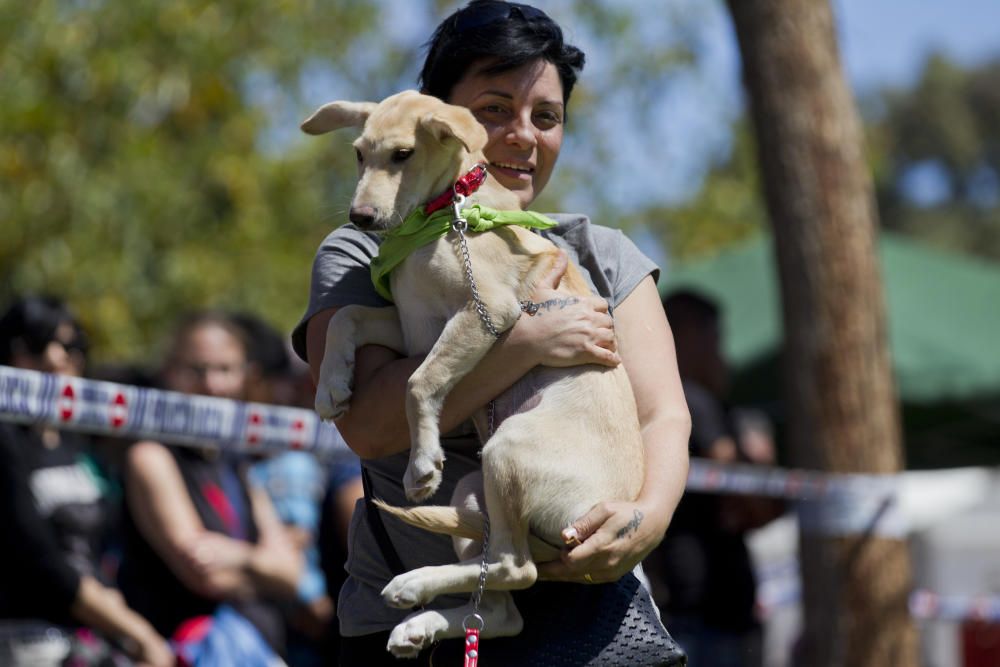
[306,255,620,458]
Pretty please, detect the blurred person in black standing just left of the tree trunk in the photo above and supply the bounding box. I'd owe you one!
[643,290,784,667]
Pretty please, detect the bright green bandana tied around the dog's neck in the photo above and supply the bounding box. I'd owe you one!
[371,204,557,301]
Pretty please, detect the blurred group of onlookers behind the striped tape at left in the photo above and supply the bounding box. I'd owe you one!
[0,296,362,667]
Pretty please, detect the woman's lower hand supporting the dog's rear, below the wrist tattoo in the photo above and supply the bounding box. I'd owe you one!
[538,502,665,584]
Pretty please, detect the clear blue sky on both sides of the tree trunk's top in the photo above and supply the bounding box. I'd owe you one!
[566,0,1000,210]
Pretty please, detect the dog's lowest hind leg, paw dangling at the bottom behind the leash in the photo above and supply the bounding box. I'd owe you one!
[386,591,524,658]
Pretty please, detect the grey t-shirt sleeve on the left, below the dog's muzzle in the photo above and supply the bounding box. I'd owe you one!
[292,226,390,361]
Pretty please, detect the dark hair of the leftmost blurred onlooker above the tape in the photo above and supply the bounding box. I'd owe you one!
[0,296,88,365]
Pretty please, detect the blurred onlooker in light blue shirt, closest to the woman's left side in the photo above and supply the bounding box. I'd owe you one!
[234,313,363,667]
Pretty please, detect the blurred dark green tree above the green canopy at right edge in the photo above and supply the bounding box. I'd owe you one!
[870,54,1000,259]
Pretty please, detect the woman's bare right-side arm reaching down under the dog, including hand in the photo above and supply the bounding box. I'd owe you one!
[539,277,691,582]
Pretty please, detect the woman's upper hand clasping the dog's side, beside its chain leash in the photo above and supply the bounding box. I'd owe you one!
[508,251,621,367]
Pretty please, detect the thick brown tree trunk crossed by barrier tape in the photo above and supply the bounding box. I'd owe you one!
[729,0,918,667]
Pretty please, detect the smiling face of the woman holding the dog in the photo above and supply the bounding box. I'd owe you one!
[448,60,565,208]
